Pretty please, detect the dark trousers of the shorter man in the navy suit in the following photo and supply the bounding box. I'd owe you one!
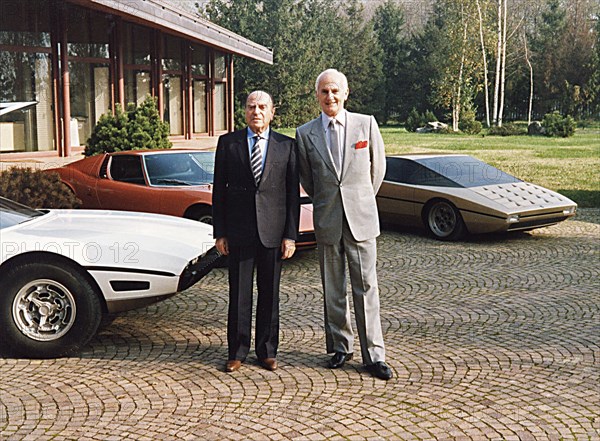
[227,243,281,361]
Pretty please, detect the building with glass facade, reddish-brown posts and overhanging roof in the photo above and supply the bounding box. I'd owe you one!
[0,0,273,156]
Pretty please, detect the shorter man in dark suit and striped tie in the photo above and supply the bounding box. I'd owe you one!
[213,91,300,372]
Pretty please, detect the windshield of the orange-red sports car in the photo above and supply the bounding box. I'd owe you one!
[144,152,215,186]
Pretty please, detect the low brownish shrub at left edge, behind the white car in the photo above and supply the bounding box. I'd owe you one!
[0,167,81,208]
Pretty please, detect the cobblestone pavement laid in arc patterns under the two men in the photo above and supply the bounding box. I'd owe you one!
[0,210,600,440]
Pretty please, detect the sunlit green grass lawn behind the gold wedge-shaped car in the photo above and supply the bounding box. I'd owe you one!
[282,127,600,208]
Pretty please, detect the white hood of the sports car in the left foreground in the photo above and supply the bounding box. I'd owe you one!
[2,210,214,274]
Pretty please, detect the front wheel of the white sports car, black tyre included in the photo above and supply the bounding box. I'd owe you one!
[0,263,102,358]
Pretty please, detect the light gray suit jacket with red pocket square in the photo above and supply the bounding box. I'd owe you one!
[296,112,385,245]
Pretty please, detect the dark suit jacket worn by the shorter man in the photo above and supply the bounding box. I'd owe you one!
[212,129,300,248]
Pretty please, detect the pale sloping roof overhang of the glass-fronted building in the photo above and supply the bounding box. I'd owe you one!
[74,0,273,64]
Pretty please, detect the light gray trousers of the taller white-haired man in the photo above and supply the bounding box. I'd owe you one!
[319,220,385,364]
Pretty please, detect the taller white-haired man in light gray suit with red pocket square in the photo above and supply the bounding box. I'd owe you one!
[296,69,392,380]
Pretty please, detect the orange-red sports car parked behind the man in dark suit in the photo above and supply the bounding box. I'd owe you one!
[47,149,316,248]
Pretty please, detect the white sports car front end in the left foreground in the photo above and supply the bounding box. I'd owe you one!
[0,197,219,358]
